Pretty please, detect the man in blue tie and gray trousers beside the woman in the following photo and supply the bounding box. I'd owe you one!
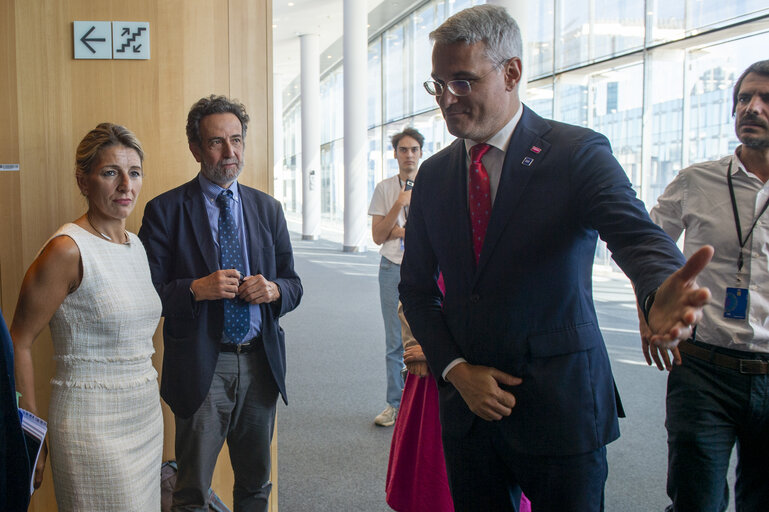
[139,95,302,511]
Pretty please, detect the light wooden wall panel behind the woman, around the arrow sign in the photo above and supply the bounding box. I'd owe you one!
[0,0,277,512]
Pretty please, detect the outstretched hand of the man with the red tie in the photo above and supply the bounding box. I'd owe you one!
[649,245,713,349]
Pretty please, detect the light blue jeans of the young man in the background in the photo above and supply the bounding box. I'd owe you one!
[379,256,403,409]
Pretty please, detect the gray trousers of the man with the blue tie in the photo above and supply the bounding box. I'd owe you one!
[172,344,278,512]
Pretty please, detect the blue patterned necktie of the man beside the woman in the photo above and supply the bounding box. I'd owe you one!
[216,190,251,343]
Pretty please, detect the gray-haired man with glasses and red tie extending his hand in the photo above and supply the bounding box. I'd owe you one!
[400,5,712,512]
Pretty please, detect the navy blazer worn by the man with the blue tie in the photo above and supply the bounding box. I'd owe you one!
[139,176,302,418]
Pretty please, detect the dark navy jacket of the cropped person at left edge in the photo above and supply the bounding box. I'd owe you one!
[0,311,30,512]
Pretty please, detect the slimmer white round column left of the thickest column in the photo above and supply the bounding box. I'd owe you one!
[299,34,320,240]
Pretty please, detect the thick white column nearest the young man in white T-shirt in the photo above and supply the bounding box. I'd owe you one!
[342,0,368,252]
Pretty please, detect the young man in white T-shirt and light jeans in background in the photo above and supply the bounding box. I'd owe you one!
[368,128,425,427]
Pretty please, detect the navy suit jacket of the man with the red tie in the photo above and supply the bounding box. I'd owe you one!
[400,107,684,455]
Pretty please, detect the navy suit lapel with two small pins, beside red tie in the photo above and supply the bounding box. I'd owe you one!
[475,106,550,280]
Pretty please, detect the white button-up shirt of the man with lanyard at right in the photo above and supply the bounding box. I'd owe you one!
[650,148,769,353]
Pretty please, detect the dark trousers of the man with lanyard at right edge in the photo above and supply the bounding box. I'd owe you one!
[665,342,769,512]
